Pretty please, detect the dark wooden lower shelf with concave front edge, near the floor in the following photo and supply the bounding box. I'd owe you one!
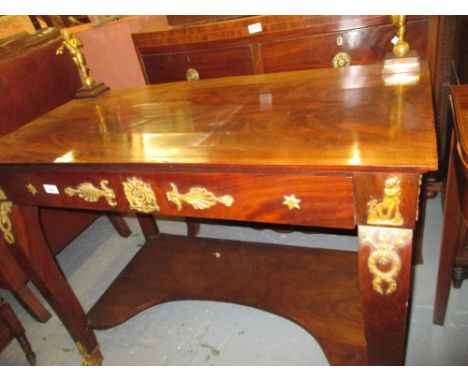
[88,235,366,364]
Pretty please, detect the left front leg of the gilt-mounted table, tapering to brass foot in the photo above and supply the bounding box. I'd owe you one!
[10,206,102,365]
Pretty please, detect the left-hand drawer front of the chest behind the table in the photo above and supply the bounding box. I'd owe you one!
[141,45,255,84]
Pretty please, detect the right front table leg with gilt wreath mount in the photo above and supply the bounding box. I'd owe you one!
[358,226,413,365]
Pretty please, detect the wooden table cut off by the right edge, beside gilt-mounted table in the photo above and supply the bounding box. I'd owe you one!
[434,85,468,325]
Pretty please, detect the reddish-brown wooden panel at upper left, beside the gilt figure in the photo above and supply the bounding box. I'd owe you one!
[0,28,81,135]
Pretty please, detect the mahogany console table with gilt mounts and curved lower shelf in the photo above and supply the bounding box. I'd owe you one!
[0,65,437,365]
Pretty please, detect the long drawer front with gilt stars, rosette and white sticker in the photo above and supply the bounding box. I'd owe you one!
[0,171,354,228]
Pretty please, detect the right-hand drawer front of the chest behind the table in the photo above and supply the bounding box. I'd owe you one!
[261,20,427,73]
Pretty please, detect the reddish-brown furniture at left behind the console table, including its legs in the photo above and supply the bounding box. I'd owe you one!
[0,28,131,321]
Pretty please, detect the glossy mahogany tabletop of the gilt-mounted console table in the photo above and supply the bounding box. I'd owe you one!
[0,65,437,172]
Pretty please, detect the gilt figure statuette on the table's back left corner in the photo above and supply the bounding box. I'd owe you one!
[55,29,109,98]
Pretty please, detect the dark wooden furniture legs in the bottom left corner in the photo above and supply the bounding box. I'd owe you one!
[0,297,36,366]
